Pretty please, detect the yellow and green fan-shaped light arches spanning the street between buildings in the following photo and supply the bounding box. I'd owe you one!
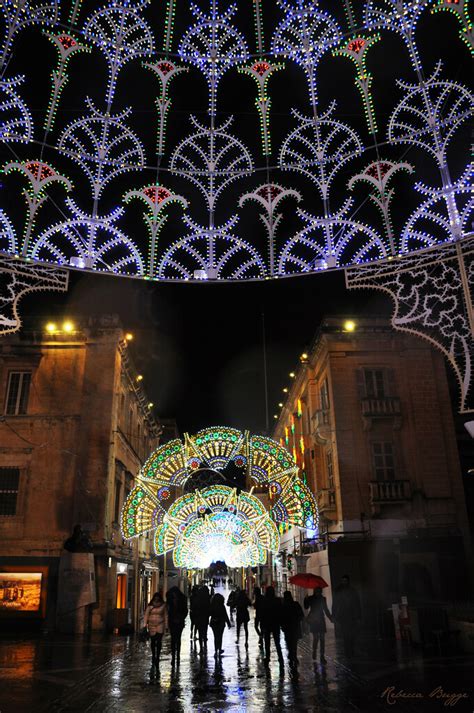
[121,426,318,569]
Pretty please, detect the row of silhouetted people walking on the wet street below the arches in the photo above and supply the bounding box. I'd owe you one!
[144,575,361,675]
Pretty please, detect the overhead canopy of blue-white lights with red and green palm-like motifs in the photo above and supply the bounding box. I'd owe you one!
[0,0,473,280]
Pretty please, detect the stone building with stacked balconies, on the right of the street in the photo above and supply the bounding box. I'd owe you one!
[273,318,471,624]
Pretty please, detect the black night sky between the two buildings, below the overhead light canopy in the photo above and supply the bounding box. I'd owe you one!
[21,271,391,432]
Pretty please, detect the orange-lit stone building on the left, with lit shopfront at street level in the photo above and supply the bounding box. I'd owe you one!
[0,316,160,631]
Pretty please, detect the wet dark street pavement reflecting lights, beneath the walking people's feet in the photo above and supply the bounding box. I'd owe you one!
[0,596,474,713]
